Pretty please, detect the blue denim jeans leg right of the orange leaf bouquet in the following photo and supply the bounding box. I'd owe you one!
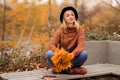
[72,50,88,67]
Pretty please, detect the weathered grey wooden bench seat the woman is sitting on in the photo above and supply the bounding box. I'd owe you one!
[0,64,120,80]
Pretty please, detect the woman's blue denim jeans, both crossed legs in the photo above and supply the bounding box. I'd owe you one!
[46,50,88,73]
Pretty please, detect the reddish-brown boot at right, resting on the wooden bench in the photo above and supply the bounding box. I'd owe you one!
[70,67,87,75]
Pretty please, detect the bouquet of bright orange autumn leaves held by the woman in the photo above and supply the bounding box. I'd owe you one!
[51,48,74,73]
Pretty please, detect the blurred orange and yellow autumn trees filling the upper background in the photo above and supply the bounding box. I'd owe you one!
[0,0,120,44]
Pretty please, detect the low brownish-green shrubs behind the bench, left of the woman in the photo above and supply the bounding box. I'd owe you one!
[0,50,50,74]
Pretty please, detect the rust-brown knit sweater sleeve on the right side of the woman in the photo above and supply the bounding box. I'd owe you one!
[72,27,85,56]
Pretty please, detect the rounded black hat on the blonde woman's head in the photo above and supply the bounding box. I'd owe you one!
[60,6,78,23]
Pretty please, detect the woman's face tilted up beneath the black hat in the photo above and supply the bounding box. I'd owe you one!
[64,10,75,24]
